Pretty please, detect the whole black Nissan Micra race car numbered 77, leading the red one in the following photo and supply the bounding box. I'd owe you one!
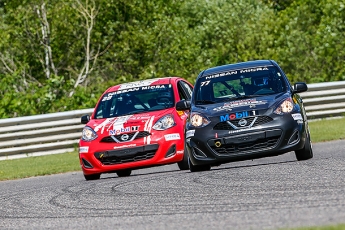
[176,60,313,172]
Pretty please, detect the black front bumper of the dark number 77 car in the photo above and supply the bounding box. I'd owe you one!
[186,114,306,165]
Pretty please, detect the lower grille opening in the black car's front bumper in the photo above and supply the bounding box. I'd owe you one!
[211,136,280,156]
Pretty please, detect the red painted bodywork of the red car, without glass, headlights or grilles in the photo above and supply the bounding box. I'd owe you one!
[79,77,192,175]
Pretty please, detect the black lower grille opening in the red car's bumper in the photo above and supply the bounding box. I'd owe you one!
[94,144,159,165]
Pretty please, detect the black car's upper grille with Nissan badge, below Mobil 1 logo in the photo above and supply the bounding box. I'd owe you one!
[213,116,273,130]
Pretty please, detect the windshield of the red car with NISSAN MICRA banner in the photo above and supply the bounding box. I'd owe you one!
[95,84,175,119]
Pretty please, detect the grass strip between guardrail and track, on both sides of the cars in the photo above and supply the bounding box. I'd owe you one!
[0,118,345,181]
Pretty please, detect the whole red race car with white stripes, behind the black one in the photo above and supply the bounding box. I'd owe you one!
[79,77,193,180]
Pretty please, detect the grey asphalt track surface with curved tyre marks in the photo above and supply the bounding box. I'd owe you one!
[0,140,345,230]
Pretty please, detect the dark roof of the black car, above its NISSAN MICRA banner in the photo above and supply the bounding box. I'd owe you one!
[199,60,277,77]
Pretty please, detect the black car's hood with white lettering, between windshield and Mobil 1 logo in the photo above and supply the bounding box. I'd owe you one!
[192,93,291,117]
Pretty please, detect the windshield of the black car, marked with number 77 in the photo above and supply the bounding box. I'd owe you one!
[194,66,286,104]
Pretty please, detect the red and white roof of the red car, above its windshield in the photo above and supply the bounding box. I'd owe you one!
[105,77,181,93]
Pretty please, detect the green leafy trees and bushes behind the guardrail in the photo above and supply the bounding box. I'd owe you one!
[0,0,345,118]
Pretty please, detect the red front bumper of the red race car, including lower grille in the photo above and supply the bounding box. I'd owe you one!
[79,129,184,175]
